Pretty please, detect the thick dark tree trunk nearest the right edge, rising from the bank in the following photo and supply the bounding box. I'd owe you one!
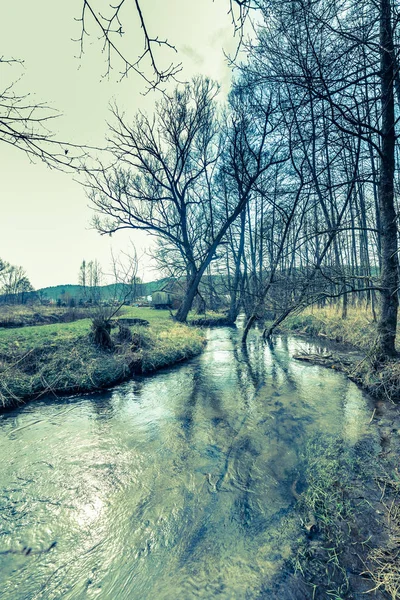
[378,0,399,358]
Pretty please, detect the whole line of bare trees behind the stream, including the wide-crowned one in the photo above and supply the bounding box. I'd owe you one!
[3,0,400,356]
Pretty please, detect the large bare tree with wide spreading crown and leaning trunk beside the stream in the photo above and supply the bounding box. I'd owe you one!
[87,78,279,321]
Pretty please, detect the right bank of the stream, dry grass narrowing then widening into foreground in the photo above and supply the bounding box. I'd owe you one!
[281,308,400,599]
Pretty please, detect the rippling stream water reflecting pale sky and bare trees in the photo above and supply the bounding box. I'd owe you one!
[0,328,372,600]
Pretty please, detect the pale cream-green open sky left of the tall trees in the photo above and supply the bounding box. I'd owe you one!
[0,0,236,289]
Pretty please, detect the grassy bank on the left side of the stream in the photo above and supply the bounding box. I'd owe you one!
[0,308,204,407]
